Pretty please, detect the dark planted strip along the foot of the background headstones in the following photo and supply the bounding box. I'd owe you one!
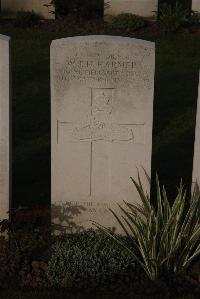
[0,17,200,39]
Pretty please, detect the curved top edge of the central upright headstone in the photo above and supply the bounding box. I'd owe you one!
[51,35,155,49]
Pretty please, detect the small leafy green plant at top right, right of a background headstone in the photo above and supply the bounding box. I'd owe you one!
[157,2,190,32]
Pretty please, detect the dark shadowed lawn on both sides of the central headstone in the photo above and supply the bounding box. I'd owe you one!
[1,19,200,299]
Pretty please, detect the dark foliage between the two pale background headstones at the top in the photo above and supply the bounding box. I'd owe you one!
[46,0,104,19]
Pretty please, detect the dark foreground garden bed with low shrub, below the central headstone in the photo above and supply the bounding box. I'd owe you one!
[0,208,200,298]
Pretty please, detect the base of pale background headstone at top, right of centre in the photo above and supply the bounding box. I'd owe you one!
[104,0,158,17]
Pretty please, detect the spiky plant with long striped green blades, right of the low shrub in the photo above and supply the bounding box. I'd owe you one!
[94,175,200,280]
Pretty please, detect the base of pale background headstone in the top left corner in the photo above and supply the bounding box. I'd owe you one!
[1,0,55,19]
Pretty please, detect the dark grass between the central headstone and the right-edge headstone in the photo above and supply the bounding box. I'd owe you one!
[152,34,200,200]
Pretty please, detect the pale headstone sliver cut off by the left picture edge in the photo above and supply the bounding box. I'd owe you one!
[0,35,11,219]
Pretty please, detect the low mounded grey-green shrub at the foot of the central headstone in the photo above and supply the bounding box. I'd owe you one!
[48,230,133,285]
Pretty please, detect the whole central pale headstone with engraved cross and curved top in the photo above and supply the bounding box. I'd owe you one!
[51,36,155,230]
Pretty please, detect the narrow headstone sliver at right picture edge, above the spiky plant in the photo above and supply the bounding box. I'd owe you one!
[192,74,200,189]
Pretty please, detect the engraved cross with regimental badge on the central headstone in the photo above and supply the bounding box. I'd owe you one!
[57,88,145,196]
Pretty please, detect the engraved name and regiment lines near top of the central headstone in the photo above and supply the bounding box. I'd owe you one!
[54,47,152,94]
